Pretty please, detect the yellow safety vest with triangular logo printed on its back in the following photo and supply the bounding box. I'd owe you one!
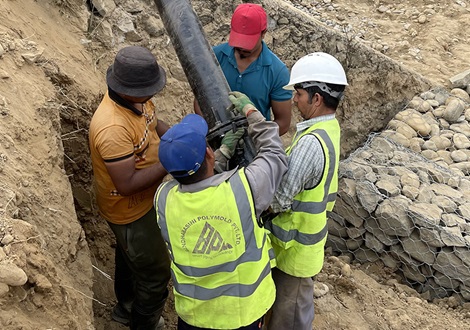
[155,169,275,329]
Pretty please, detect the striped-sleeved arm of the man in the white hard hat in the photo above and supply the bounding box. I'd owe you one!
[271,135,325,213]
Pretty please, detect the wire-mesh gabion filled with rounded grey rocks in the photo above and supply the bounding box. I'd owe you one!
[328,88,470,301]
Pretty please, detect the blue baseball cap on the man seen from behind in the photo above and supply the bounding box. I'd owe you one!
[158,113,208,178]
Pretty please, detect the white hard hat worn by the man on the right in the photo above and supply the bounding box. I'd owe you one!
[283,52,348,90]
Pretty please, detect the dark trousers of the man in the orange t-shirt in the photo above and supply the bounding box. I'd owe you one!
[108,207,170,330]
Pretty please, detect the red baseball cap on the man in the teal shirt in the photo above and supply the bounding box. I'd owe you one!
[228,3,268,49]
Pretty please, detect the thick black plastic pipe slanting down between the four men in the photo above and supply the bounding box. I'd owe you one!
[155,0,256,166]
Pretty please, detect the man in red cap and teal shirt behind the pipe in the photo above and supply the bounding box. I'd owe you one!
[195,3,292,135]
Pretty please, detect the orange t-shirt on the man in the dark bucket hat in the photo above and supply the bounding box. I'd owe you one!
[89,93,160,224]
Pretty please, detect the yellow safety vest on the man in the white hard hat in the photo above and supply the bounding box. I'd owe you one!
[266,119,340,277]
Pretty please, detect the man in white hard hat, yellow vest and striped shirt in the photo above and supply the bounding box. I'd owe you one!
[265,52,348,330]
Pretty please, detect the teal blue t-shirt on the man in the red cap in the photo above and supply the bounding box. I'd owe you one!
[213,41,292,120]
